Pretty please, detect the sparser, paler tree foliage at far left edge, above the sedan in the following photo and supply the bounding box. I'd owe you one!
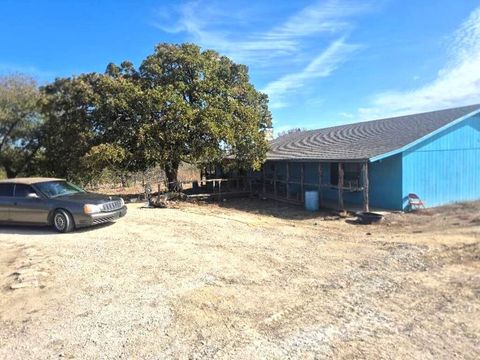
[0,74,42,177]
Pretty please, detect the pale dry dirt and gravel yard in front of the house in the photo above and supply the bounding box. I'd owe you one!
[0,200,480,359]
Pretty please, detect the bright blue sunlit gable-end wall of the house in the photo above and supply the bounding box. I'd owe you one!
[402,115,480,208]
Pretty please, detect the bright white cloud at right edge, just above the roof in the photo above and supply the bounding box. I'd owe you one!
[359,7,480,119]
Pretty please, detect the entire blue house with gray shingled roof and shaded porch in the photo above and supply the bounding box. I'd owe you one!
[257,105,480,211]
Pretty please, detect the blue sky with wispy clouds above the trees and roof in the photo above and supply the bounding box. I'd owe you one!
[0,0,480,132]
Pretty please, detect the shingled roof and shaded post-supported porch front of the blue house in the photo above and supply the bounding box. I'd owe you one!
[262,104,480,211]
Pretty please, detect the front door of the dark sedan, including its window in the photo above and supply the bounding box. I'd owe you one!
[10,184,49,224]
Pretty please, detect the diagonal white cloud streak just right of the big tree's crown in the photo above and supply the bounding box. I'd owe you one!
[262,38,360,108]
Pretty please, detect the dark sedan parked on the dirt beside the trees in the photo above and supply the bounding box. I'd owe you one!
[0,178,127,232]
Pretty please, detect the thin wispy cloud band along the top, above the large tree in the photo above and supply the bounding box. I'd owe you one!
[153,0,370,65]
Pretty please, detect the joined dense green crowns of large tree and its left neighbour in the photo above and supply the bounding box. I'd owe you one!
[42,44,271,187]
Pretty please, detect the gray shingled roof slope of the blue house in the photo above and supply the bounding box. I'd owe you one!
[267,104,480,161]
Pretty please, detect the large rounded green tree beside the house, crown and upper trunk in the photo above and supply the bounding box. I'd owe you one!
[139,44,271,186]
